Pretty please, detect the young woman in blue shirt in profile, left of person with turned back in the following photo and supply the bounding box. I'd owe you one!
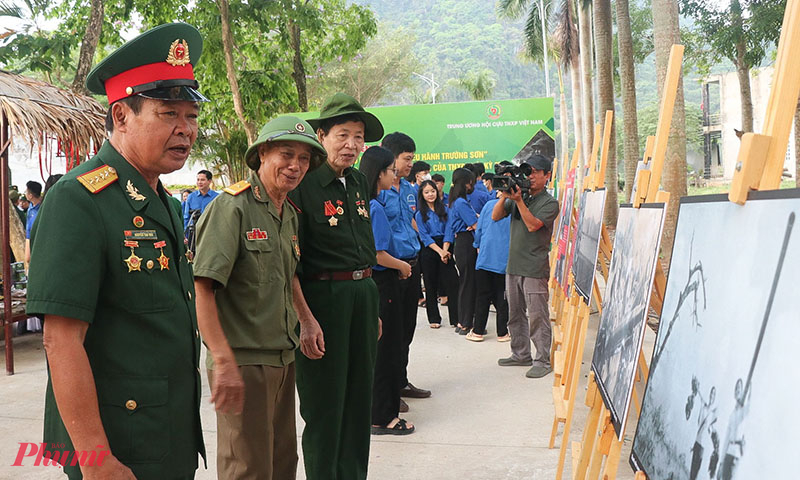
[447,168,478,335]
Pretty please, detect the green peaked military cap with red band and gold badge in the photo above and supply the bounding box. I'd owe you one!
[86,23,208,105]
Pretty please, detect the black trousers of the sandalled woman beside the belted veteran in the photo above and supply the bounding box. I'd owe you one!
[372,270,403,426]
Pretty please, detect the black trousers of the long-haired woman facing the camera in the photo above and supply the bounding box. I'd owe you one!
[419,237,458,326]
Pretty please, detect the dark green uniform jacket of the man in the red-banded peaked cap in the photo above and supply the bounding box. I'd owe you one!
[27,142,205,479]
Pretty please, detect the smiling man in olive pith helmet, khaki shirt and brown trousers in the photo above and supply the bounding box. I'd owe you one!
[194,116,325,480]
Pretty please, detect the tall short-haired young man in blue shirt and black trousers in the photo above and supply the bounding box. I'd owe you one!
[378,132,431,398]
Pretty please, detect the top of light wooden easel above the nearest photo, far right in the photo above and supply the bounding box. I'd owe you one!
[636,0,800,480]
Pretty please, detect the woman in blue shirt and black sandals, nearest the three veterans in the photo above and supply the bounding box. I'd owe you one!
[359,146,414,435]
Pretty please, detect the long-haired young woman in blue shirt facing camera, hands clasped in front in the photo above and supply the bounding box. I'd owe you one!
[415,180,458,328]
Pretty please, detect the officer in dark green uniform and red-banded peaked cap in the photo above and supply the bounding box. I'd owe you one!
[27,23,206,479]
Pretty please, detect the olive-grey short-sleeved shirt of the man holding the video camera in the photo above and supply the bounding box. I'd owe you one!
[503,190,558,278]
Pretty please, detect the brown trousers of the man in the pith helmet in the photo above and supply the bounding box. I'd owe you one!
[208,363,297,480]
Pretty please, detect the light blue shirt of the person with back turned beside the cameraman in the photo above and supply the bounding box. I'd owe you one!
[472,198,511,274]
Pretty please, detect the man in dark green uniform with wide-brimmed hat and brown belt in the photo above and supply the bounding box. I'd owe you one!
[289,93,383,480]
